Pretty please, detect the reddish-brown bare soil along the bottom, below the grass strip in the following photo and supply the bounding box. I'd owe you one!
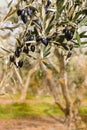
[0,117,67,130]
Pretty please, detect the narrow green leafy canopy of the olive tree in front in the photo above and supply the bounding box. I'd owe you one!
[1,0,87,68]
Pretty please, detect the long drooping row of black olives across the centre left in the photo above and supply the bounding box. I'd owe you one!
[10,29,57,67]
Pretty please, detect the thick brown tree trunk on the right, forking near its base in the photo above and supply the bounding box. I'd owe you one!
[50,49,86,130]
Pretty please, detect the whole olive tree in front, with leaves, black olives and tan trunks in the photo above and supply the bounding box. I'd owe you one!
[0,0,87,129]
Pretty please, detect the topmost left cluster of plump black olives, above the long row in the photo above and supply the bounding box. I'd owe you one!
[17,8,35,24]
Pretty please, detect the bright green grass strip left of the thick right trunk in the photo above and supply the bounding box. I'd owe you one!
[0,103,63,118]
